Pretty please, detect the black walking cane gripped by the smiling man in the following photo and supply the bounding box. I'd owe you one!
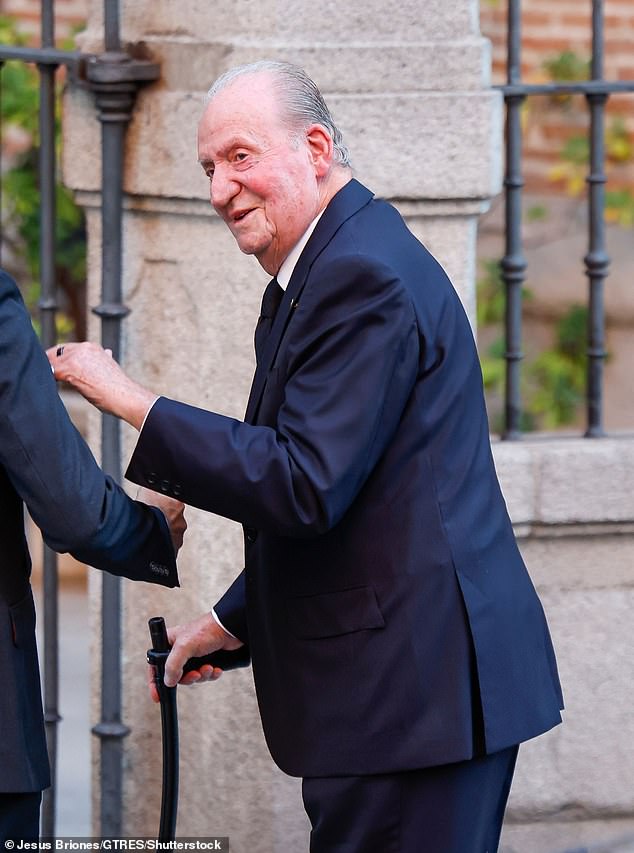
[147,616,250,841]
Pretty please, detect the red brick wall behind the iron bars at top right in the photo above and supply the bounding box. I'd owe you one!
[480,0,634,191]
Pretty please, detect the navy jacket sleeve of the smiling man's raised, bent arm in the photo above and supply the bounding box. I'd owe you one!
[126,256,419,536]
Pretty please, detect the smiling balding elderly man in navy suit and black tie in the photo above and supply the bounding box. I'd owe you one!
[50,62,562,853]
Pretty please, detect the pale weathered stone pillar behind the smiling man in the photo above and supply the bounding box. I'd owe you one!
[64,0,501,853]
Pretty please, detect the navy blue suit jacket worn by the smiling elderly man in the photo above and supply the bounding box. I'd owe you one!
[127,181,561,776]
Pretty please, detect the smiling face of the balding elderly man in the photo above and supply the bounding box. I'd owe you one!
[198,72,332,275]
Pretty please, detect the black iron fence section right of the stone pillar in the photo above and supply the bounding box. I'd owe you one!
[500,0,634,439]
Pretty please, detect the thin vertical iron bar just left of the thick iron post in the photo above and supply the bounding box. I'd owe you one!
[38,0,61,838]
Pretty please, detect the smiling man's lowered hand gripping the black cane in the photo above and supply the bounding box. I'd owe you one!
[148,613,243,702]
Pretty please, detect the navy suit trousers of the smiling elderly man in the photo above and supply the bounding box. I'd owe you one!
[302,746,518,853]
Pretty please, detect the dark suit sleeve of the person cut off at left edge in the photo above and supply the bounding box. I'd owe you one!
[0,272,178,586]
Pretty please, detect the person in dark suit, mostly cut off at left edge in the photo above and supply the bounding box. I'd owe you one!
[0,270,186,841]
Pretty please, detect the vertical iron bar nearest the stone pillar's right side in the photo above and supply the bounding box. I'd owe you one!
[500,0,526,439]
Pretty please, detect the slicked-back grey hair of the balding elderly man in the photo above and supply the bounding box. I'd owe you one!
[207,59,350,166]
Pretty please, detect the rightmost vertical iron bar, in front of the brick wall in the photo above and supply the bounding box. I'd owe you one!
[584,0,610,438]
